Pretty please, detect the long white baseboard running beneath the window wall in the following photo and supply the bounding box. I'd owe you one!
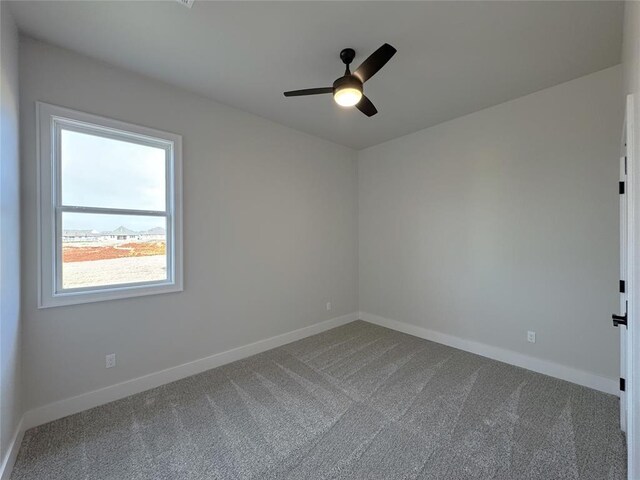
[22,312,358,430]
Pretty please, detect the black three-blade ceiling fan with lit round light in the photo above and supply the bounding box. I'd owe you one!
[284,43,397,117]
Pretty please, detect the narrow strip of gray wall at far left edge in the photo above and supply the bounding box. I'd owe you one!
[0,2,22,464]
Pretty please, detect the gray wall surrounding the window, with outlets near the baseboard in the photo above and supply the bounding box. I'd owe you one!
[20,38,358,408]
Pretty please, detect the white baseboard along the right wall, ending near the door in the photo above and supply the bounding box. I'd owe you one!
[360,312,620,396]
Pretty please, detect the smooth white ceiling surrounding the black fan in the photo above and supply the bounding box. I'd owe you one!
[7,0,623,149]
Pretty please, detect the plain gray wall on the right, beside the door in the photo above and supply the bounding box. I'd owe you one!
[358,66,623,378]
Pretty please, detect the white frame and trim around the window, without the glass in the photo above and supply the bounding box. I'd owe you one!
[36,102,183,308]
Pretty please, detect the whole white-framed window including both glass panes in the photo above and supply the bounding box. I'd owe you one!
[37,103,182,308]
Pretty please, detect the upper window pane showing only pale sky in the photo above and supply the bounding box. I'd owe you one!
[60,129,166,211]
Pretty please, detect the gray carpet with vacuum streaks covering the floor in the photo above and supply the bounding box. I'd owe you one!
[11,321,626,480]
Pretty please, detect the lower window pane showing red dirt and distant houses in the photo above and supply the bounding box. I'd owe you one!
[62,212,167,289]
